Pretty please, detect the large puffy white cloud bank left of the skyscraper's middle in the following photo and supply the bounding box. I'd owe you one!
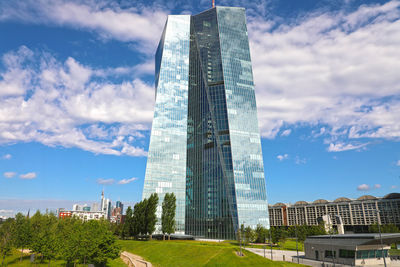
[0,46,154,156]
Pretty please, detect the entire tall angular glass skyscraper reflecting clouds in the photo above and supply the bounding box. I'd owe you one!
[143,7,269,239]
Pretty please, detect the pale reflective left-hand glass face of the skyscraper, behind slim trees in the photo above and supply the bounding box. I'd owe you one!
[143,15,190,233]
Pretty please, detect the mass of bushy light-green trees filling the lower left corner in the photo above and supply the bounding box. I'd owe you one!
[0,211,120,266]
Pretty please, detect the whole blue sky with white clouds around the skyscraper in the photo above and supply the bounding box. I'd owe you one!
[0,0,400,216]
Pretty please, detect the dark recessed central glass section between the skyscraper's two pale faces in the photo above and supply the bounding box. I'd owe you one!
[185,9,237,239]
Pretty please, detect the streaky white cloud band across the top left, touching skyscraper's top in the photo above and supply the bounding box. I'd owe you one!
[0,0,167,53]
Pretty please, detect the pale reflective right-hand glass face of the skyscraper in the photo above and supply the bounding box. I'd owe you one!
[217,7,269,230]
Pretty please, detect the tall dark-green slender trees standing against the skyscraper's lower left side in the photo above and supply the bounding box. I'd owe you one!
[116,193,176,240]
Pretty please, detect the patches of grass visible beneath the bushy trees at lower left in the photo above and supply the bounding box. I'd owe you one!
[0,250,126,267]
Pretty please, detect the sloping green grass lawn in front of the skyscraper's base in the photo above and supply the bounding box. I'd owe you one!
[119,240,304,267]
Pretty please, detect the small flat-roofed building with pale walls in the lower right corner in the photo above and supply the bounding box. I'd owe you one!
[304,234,400,266]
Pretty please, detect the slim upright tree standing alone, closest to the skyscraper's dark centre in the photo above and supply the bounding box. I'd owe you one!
[161,193,176,240]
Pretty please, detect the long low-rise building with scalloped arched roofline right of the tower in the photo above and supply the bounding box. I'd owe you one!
[269,193,400,231]
